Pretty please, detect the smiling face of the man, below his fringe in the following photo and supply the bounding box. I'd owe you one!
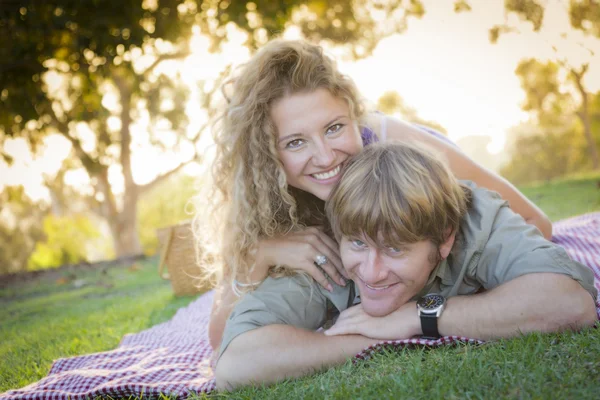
[340,237,439,317]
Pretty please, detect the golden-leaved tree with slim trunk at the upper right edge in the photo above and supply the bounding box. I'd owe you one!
[490,0,600,169]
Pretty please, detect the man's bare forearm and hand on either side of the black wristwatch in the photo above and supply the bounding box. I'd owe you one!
[326,273,598,340]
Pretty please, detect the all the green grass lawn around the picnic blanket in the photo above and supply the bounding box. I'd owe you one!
[0,174,600,399]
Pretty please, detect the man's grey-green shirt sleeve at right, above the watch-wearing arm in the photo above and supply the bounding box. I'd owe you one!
[468,203,597,299]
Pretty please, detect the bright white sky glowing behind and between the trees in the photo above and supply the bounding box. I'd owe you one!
[0,0,600,199]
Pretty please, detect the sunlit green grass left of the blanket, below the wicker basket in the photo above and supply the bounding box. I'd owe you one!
[0,261,197,393]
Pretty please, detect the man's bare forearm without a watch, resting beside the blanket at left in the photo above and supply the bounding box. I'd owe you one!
[215,325,378,390]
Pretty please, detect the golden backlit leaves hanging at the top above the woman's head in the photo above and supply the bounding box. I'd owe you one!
[199,0,425,57]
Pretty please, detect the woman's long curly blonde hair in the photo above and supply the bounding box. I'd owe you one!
[195,40,364,281]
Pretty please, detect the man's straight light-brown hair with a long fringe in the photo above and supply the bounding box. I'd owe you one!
[326,142,471,253]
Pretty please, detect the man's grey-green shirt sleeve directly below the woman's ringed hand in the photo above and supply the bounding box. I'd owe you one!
[219,275,327,357]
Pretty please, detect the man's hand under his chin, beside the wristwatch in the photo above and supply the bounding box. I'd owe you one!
[325,302,422,340]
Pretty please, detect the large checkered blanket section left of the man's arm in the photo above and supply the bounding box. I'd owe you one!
[0,291,215,400]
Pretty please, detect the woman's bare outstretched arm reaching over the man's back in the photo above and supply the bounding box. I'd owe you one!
[380,117,552,239]
